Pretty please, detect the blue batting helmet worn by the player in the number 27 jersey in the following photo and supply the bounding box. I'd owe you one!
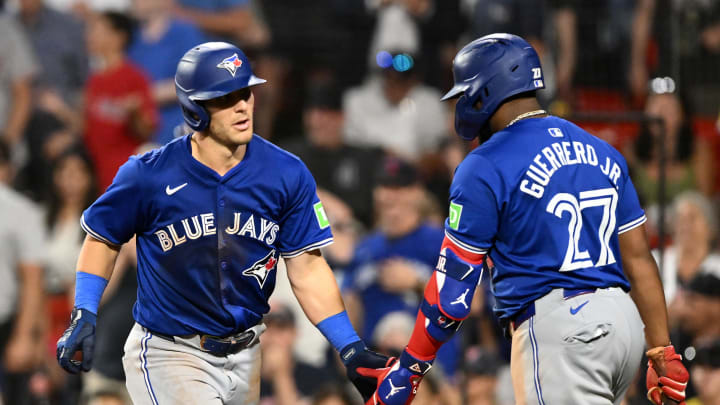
[442,34,545,140]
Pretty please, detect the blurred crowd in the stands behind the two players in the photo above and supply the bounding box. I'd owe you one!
[0,0,720,405]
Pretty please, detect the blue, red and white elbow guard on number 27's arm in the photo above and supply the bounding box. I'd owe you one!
[420,248,483,342]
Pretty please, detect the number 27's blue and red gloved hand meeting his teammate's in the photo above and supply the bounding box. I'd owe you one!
[359,350,432,405]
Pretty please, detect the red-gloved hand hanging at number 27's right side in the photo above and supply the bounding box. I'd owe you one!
[645,346,690,405]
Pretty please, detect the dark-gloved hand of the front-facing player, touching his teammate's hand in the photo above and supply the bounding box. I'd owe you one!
[340,340,392,401]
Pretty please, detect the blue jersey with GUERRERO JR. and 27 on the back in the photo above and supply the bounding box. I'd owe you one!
[445,117,645,319]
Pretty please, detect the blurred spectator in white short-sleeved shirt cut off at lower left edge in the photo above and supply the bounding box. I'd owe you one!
[0,138,46,405]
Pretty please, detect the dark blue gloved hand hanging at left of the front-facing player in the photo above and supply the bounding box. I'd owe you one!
[56,308,97,374]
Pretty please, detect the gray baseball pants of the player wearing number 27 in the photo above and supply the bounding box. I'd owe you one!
[510,288,645,405]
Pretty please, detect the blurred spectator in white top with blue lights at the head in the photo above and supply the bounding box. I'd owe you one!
[344,51,447,161]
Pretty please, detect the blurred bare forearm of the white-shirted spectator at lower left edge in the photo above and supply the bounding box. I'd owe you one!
[13,264,44,338]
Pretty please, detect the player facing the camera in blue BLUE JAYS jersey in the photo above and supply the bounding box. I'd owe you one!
[57,42,386,405]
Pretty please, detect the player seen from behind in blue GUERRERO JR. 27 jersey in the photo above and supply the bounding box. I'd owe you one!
[368,34,688,405]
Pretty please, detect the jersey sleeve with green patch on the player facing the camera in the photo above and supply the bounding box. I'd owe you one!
[278,164,333,258]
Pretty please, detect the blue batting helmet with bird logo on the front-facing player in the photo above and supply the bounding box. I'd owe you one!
[175,42,265,131]
